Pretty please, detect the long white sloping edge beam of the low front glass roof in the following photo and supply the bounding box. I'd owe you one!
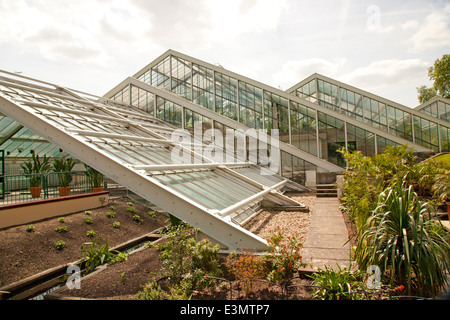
[0,97,268,251]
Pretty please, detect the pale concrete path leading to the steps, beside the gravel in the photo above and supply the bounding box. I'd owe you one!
[302,197,351,270]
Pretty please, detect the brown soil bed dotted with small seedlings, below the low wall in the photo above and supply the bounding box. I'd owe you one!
[0,198,167,287]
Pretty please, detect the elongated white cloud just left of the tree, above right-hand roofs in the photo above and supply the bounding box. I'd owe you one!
[340,59,428,90]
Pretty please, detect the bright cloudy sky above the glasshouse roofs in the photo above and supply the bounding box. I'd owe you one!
[0,0,450,107]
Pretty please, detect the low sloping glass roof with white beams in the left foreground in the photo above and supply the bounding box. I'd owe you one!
[0,70,310,250]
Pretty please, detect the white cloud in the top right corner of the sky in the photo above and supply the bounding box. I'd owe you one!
[408,4,450,53]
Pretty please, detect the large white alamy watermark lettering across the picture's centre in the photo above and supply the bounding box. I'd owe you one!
[171,124,281,175]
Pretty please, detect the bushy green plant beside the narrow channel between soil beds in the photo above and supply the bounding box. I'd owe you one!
[81,238,128,273]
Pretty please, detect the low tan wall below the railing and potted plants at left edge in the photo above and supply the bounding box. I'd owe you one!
[0,191,109,229]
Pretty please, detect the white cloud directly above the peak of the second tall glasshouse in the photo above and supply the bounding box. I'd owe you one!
[273,58,347,87]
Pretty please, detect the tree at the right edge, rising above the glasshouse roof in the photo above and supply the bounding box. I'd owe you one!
[417,54,450,103]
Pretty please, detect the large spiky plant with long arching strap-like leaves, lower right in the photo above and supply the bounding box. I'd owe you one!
[355,182,450,296]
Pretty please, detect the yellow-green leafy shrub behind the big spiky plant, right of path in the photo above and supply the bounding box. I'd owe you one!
[341,146,445,229]
